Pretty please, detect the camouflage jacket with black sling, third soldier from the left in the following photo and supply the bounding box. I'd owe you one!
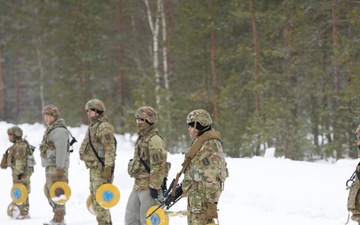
[79,116,116,168]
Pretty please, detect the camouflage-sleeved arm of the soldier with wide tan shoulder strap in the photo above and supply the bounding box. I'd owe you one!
[197,139,221,203]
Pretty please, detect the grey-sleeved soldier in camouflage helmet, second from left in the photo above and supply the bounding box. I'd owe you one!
[40,105,70,225]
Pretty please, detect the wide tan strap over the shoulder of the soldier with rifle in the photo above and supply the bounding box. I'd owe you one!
[172,130,221,196]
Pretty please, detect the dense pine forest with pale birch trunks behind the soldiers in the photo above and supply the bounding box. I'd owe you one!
[0,0,360,161]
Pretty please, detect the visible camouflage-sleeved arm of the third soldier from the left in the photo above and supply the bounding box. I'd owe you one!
[97,122,115,167]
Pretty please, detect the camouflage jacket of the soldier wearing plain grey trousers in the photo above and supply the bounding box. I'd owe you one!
[128,126,168,190]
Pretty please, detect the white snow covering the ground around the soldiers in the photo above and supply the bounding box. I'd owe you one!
[0,122,358,225]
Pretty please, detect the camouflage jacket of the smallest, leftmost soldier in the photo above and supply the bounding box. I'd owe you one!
[7,139,32,176]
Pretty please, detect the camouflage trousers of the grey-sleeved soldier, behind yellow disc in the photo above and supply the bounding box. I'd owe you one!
[44,166,68,217]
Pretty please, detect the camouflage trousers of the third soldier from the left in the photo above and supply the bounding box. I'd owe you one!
[90,166,112,225]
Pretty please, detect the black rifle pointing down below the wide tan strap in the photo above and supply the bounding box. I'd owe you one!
[146,179,183,219]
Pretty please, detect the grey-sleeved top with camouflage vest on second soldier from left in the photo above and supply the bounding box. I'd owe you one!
[40,118,70,168]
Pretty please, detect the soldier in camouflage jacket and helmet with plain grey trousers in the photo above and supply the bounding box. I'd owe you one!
[125,106,169,225]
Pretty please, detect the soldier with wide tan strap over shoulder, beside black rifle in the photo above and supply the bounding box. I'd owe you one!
[182,109,228,225]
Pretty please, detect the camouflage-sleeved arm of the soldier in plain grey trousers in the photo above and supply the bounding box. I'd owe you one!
[149,135,167,190]
